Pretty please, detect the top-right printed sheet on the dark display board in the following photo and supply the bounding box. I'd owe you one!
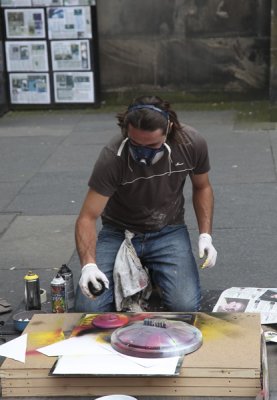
[47,6,92,39]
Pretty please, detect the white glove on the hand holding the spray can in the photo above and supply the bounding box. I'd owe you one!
[79,263,109,299]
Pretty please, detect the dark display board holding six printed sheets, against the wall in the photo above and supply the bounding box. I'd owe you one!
[0,0,99,108]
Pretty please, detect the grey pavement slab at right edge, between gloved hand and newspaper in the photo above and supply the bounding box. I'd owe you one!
[196,227,276,289]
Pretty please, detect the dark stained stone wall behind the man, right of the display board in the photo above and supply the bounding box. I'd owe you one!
[97,0,270,95]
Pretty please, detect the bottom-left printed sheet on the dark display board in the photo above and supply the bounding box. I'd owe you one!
[10,73,50,104]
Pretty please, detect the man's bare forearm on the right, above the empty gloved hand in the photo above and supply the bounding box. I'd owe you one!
[193,186,214,234]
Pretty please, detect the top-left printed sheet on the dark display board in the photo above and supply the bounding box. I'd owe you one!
[5,8,45,39]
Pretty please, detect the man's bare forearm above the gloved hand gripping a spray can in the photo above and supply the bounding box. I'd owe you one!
[75,217,96,266]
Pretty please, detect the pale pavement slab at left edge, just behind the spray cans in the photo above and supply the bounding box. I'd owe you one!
[0,215,76,272]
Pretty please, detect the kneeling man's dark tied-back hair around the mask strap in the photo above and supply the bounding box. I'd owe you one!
[117,96,186,142]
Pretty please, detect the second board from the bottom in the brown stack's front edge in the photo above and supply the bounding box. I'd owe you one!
[2,378,261,388]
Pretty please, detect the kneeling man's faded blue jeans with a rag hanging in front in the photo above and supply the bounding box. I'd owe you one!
[75,224,201,313]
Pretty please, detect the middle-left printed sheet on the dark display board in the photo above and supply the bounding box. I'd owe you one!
[5,41,48,71]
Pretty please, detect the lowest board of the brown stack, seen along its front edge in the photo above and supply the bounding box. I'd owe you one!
[2,386,261,397]
